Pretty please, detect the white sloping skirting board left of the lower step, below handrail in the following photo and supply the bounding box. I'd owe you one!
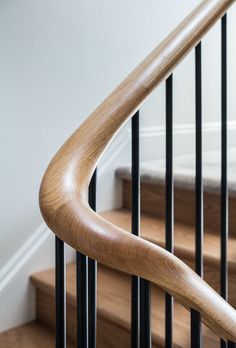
[0,223,75,332]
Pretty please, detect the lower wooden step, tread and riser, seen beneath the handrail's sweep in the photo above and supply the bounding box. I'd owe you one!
[32,264,219,348]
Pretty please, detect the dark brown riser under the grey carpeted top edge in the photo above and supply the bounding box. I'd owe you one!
[123,180,236,237]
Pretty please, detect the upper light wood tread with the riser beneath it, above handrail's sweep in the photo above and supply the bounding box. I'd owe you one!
[101,209,236,308]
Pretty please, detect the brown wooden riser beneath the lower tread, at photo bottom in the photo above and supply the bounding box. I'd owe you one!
[36,288,160,348]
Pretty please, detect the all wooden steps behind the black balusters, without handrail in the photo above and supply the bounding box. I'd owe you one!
[0,157,236,348]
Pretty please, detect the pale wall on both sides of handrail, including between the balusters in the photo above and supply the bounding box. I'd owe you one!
[0,0,236,328]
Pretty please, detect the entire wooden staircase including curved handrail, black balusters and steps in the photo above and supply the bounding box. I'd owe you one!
[0,0,236,348]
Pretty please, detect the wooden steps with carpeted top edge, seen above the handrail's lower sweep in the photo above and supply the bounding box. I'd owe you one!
[115,163,236,308]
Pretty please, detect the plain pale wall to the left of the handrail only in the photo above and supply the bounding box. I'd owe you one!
[0,0,203,267]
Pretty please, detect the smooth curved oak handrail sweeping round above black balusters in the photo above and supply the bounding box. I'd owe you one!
[40,0,236,341]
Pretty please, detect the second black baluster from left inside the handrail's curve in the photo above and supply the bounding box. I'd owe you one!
[131,111,140,348]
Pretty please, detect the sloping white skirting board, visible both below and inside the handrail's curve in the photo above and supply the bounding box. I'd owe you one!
[0,124,129,332]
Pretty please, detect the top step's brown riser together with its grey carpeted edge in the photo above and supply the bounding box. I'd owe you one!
[116,168,236,237]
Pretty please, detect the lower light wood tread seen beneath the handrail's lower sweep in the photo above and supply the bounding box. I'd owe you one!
[31,263,218,348]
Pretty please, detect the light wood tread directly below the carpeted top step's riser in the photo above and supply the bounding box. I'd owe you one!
[101,209,236,272]
